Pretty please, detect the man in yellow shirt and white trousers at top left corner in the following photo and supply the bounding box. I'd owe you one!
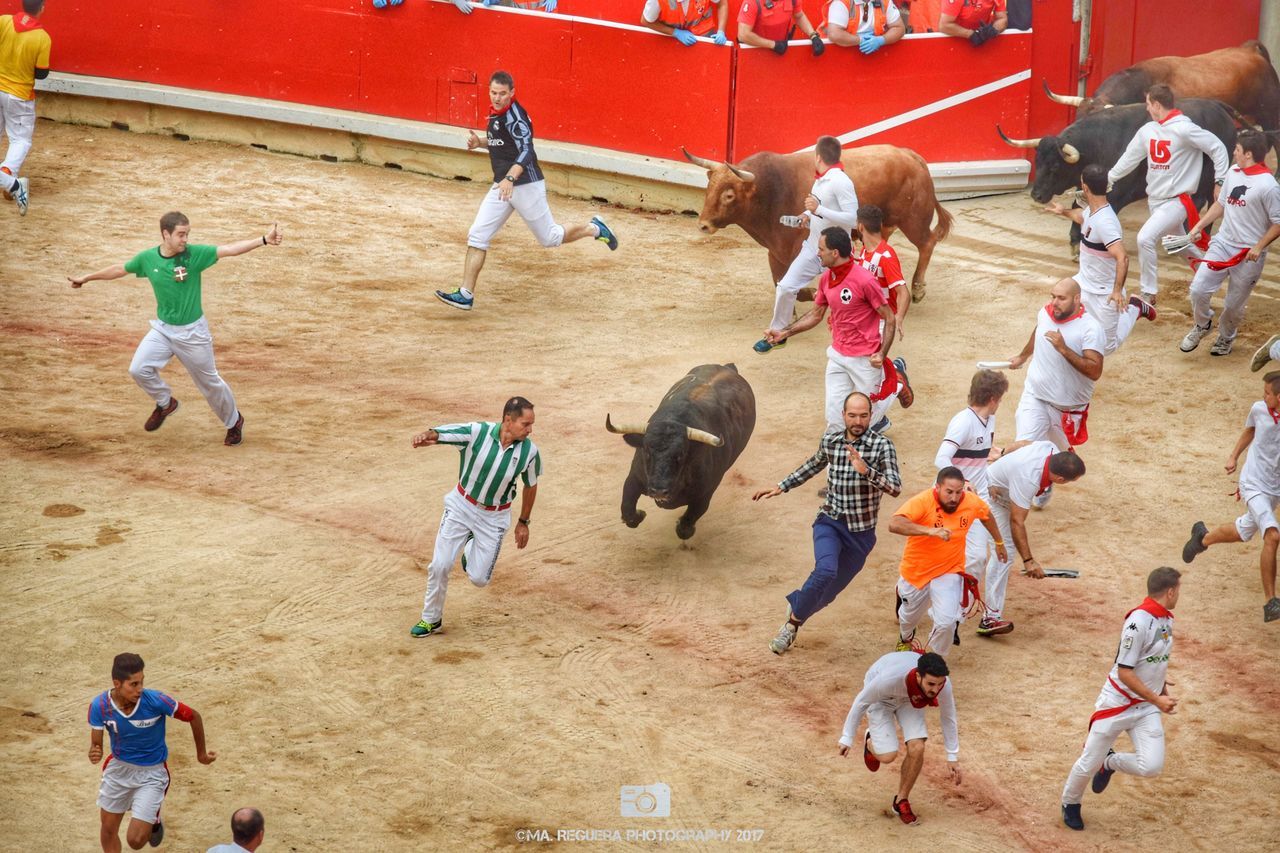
[0,0,52,216]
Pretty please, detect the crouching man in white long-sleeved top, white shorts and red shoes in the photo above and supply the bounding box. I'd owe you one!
[840,652,963,826]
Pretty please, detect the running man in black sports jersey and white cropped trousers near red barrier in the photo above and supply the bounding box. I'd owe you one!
[435,70,618,311]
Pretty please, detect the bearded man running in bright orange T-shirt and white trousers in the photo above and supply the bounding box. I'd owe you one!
[888,465,1009,657]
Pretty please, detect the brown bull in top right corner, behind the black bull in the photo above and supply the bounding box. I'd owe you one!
[1044,41,1280,163]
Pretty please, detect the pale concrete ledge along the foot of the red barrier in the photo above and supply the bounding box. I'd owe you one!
[36,72,1029,211]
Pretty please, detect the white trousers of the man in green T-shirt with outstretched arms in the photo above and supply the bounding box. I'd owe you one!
[129,318,239,429]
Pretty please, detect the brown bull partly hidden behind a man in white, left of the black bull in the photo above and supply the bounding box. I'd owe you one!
[681,145,951,302]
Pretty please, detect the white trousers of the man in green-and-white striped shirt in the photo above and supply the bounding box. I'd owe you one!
[422,488,511,624]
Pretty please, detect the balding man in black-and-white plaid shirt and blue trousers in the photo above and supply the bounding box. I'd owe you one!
[751,391,902,654]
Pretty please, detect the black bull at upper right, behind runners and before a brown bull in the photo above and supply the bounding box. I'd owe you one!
[996,97,1235,246]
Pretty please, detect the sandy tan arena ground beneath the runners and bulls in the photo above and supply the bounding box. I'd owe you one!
[0,122,1280,852]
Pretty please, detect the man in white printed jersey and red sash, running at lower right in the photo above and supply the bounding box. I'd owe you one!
[1062,566,1181,830]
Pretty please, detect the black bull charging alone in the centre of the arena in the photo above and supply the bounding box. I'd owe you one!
[604,364,755,539]
